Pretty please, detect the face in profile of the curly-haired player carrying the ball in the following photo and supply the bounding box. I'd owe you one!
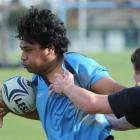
[20,40,53,74]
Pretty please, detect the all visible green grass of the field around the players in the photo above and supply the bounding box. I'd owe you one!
[0,51,140,140]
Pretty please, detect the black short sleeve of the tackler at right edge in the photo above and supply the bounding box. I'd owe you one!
[108,87,140,118]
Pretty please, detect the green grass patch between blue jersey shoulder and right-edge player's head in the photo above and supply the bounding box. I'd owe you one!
[88,51,134,86]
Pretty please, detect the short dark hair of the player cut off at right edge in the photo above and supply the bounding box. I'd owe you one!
[131,48,140,71]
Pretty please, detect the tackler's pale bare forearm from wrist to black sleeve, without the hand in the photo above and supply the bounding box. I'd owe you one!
[64,85,111,114]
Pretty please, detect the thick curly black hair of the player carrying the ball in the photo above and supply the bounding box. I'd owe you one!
[16,7,70,55]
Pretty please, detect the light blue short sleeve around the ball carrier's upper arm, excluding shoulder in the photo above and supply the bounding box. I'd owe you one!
[78,59,110,89]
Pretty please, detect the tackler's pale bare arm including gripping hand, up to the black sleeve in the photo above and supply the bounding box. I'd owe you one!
[51,72,112,114]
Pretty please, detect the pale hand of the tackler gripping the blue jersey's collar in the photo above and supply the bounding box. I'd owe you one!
[51,71,74,94]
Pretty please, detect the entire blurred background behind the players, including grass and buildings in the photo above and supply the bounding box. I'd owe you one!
[0,0,140,140]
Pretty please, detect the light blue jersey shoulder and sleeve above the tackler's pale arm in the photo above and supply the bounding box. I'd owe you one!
[65,53,109,89]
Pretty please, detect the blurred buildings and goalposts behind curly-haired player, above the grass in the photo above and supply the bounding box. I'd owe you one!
[0,0,140,63]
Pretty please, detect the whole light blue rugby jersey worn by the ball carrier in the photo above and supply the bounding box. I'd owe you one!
[33,52,111,140]
